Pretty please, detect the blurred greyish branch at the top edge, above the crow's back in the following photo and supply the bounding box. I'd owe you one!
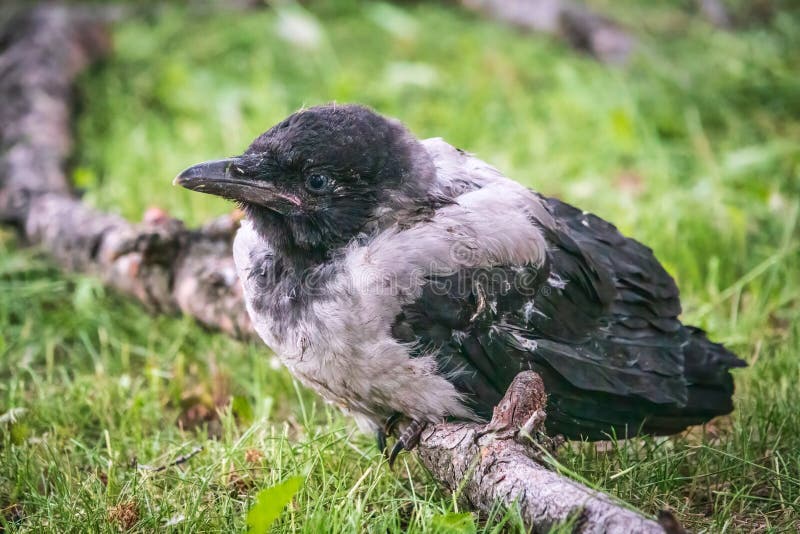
[460,0,635,63]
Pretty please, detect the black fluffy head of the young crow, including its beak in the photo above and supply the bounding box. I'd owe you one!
[173,105,435,264]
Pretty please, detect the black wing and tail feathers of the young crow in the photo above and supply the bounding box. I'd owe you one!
[393,197,744,439]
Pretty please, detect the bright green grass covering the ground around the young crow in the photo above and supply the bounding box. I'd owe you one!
[0,0,800,532]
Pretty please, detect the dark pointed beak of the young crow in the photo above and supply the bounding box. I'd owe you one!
[172,158,301,211]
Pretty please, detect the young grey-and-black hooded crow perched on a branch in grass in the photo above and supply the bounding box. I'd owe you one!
[174,104,745,463]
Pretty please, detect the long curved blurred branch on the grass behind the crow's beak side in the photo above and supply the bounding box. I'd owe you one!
[0,6,253,338]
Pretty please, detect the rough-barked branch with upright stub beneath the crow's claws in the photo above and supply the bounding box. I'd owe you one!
[419,371,665,534]
